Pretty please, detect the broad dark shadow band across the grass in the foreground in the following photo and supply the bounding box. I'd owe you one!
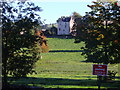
[9,77,120,89]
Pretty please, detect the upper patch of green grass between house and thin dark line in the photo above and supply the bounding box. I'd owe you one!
[48,38,84,50]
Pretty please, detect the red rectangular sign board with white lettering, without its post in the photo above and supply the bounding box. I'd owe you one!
[93,64,107,76]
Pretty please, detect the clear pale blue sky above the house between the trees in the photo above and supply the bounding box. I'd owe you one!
[34,0,92,24]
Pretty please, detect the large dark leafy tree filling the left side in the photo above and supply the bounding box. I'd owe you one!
[2,2,41,86]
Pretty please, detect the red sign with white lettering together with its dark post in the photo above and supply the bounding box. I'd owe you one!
[93,64,107,90]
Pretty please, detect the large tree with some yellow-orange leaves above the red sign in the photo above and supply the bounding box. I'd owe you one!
[74,2,120,64]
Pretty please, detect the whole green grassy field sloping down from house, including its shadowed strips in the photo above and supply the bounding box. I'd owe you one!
[9,38,120,88]
